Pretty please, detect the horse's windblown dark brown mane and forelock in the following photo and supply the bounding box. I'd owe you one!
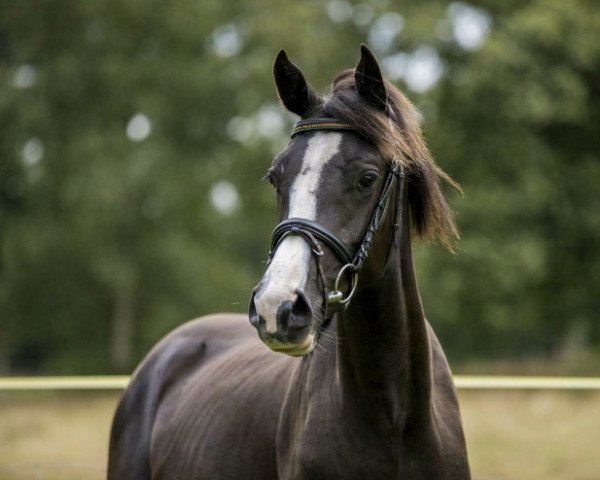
[323,69,460,250]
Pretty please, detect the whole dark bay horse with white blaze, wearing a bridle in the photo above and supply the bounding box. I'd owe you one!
[108,46,470,480]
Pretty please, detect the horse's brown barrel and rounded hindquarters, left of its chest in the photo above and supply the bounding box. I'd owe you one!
[108,315,294,480]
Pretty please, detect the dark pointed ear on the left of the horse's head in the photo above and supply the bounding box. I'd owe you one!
[273,49,321,117]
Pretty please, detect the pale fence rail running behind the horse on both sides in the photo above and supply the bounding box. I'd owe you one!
[0,375,600,391]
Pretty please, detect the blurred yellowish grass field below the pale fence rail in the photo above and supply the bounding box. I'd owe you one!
[0,391,600,480]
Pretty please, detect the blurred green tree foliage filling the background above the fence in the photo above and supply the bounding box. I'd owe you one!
[0,0,600,373]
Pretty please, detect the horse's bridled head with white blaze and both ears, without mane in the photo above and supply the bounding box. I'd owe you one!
[250,46,404,356]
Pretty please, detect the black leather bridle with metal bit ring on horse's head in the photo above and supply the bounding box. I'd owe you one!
[269,118,405,318]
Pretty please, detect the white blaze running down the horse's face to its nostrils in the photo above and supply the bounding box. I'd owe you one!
[254,132,342,333]
